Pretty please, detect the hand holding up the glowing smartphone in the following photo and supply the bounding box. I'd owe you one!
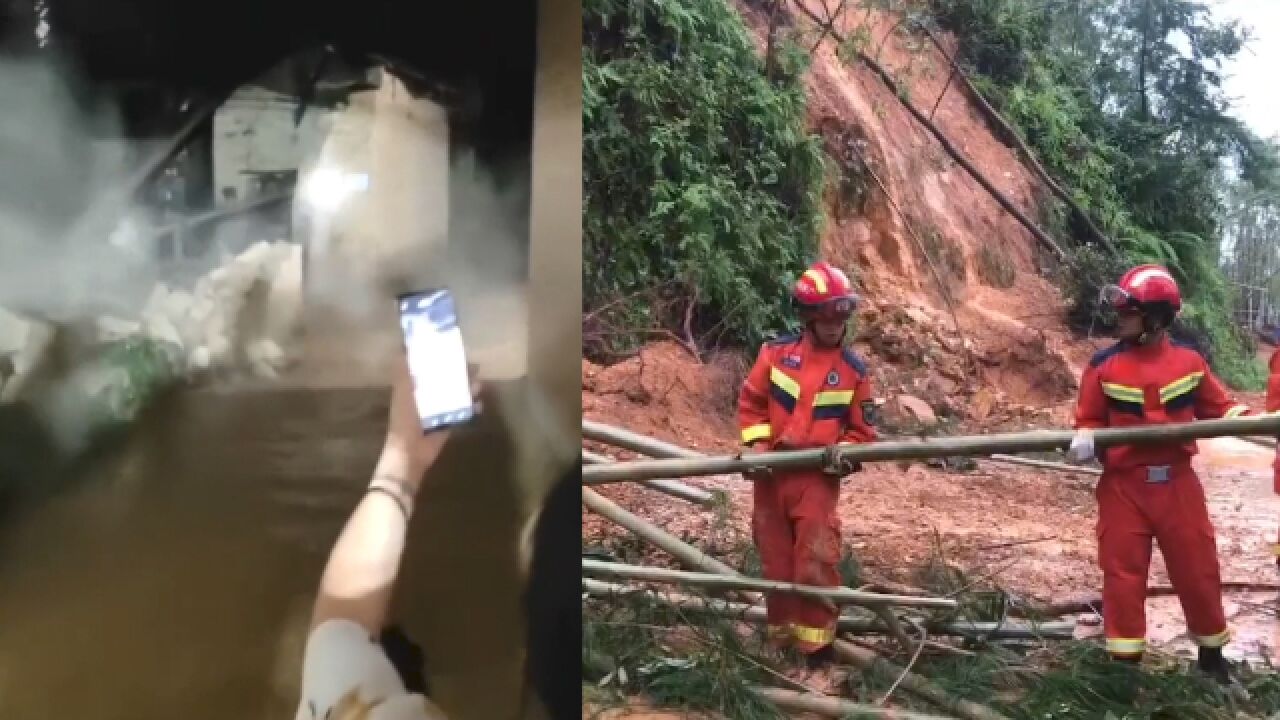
[374,352,483,489]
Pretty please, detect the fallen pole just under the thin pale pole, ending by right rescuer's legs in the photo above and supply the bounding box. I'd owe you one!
[582,578,1075,639]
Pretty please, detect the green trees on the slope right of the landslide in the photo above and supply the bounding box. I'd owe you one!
[932,0,1275,387]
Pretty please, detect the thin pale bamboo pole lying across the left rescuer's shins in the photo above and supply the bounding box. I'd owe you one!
[582,557,956,609]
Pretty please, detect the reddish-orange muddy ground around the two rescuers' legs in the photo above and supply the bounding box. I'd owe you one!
[582,345,1280,656]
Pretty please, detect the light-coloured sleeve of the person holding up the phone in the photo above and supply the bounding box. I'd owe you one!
[294,619,421,720]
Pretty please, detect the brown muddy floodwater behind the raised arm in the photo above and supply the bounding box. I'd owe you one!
[0,379,532,720]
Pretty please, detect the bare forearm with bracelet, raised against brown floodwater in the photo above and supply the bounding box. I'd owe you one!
[311,447,422,637]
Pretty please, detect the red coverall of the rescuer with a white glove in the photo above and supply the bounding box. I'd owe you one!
[1075,337,1251,657]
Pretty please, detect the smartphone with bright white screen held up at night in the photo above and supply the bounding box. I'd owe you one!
[397,290,475,433]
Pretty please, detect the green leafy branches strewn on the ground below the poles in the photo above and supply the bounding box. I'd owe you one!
[582,530,1280,720]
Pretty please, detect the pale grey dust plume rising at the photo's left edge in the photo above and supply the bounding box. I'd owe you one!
[0,60,157,323]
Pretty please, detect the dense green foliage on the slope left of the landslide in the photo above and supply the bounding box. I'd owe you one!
[582,0,824,354]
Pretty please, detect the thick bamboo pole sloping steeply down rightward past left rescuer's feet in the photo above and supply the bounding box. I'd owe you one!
[582,488,1006,720]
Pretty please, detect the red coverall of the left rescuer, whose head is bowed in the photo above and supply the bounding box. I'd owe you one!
[739,333,876,652]
